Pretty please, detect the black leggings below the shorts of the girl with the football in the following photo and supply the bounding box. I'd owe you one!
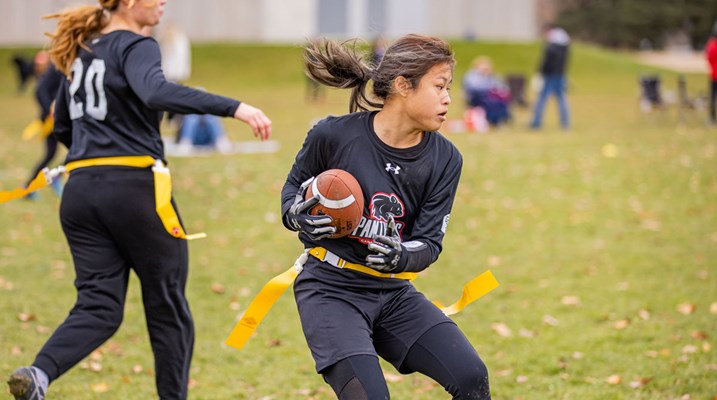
[322,323,490,400]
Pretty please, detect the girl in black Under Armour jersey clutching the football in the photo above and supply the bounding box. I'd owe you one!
[281,35,490,399]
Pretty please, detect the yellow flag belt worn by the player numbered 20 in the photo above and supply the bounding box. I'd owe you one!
[0,156,207,240]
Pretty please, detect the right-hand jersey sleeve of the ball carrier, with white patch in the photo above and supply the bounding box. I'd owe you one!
[403,148,463,272]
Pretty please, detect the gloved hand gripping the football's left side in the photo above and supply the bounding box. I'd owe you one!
[286,177,336,240]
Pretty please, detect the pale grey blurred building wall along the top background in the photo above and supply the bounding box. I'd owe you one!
[0,0,536,46]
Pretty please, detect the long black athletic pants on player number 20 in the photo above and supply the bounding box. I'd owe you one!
[33,166,194,399]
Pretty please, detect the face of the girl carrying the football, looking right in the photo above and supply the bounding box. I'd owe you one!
[406,63,453,131]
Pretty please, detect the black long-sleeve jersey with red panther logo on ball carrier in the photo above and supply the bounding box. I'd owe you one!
[281,112,463,271]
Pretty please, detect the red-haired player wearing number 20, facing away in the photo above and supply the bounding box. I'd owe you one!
[8,0,271,400]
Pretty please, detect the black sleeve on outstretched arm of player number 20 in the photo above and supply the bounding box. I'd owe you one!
[123,38,240,117]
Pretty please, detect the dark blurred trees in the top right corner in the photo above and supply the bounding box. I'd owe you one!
[557,0,717,49]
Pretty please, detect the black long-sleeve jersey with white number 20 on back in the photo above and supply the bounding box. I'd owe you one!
[54,30,239,161]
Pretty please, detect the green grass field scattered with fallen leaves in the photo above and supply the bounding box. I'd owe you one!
[0,39,717,400]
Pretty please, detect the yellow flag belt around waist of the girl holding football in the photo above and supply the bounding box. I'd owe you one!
[224,247,500,349]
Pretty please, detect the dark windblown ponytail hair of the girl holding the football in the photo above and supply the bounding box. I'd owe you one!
[304,34,455,112]
